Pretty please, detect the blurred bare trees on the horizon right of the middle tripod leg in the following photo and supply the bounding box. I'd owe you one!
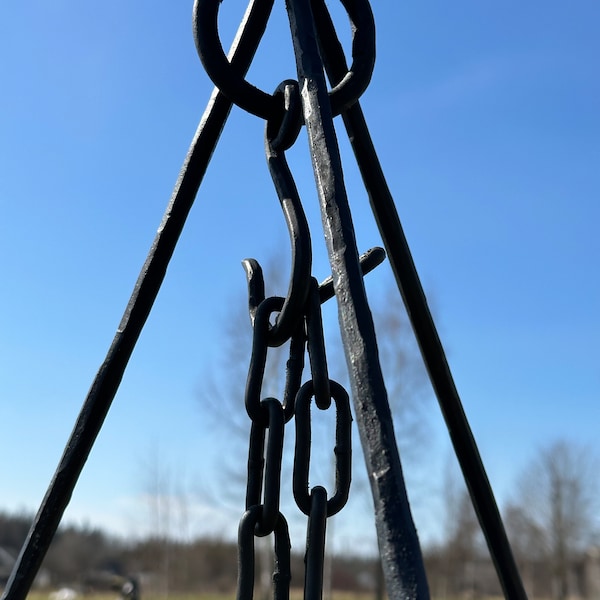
[428,440,600,600]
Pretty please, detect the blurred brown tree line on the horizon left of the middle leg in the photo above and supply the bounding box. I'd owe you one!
[0,512,376,598]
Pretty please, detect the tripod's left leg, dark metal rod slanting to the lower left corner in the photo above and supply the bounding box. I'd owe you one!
[2,0,272,600]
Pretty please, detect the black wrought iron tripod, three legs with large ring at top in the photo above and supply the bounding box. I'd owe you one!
[3,0,526,600]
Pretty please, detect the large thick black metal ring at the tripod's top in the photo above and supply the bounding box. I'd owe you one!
[193,0,375,119]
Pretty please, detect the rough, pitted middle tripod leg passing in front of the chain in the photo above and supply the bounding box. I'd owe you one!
[288,0,429,598]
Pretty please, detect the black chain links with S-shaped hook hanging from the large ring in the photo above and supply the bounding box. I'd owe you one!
[237,75,384,600]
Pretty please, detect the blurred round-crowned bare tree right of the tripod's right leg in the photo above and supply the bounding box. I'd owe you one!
[509,440,599,600]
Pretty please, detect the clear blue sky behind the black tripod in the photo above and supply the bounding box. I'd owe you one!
[0,0,600,552]
